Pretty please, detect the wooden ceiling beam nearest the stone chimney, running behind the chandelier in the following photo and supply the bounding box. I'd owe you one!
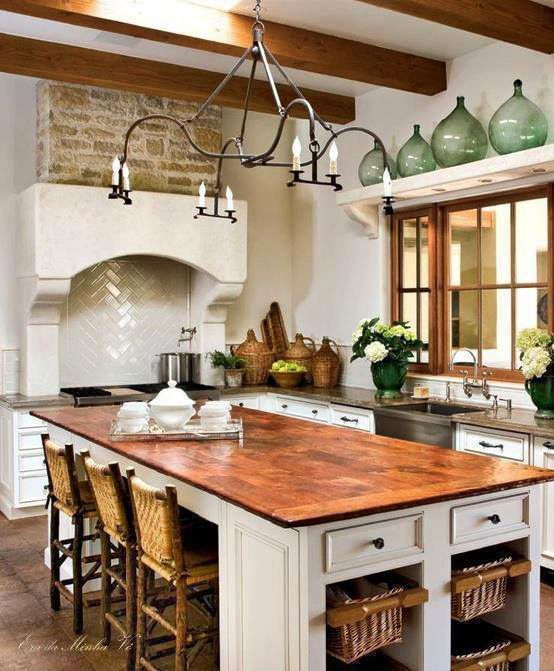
[0,34,355,124]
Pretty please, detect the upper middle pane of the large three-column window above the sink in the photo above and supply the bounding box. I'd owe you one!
[481,203,511,284]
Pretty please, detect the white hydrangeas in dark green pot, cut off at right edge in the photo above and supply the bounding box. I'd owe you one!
[516,328,554,419]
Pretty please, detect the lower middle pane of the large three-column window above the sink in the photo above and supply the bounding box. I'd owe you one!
[481,289,512,368]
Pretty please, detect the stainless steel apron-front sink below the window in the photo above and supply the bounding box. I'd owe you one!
[373,401,484,448]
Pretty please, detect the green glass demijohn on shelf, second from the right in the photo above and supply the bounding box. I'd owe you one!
[431,96,488,168]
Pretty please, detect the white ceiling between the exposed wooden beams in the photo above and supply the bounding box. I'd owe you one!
[0,0,496,96]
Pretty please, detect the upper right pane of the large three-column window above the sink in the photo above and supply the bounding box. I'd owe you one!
[516,198,548,283]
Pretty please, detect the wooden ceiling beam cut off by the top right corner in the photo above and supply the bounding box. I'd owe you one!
[356,0,554,54]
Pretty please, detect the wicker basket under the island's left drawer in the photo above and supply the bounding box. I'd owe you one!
[327,578,408,664]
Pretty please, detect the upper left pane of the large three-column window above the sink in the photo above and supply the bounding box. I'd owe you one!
[449,210,479,286]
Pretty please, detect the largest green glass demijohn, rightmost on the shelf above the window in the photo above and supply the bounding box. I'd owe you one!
[489,79,548,154]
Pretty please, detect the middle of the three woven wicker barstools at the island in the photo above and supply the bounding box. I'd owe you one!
[81,450,137,671]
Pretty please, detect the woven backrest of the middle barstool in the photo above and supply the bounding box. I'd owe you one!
[81,450,134,543]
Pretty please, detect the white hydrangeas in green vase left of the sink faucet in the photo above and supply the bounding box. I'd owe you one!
[350,317,423,398]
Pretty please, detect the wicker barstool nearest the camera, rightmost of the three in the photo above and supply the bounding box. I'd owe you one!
[127,469,219,671]
